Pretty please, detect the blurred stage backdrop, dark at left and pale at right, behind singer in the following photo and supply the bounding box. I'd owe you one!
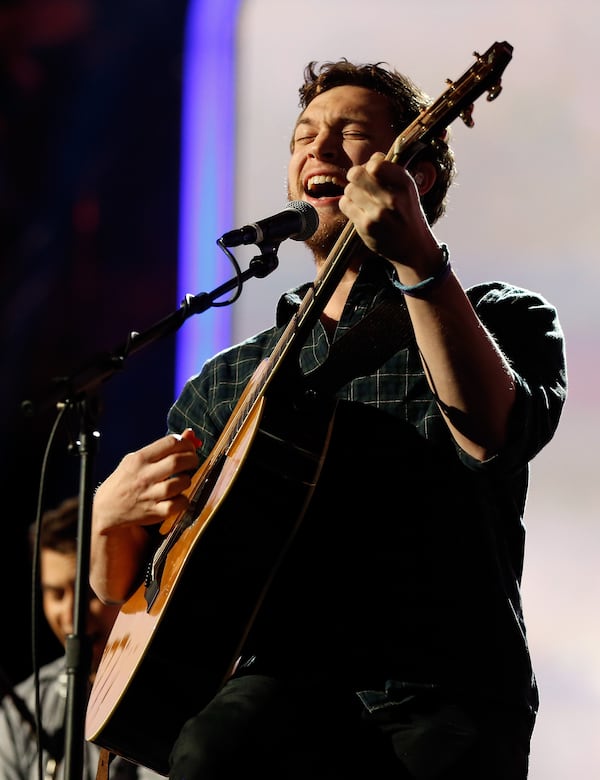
[0,0,600,780]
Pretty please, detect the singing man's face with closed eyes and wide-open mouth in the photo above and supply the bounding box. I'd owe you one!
[288,86,396,251]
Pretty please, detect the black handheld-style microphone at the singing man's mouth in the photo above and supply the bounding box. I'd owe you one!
[219,200,319,247]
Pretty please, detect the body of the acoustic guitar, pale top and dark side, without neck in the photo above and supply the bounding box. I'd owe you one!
[85,390,333,775]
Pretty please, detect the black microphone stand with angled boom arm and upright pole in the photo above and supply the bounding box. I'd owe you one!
[21,242,279,780]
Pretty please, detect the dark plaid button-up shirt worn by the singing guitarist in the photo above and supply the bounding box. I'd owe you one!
[168,261,566,710]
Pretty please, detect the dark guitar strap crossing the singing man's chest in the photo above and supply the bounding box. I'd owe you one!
[305,298,415,395]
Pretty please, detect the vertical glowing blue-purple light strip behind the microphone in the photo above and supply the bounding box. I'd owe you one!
[175,0,241,395]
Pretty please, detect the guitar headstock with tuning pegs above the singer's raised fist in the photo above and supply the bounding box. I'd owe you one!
[388,41,513,164]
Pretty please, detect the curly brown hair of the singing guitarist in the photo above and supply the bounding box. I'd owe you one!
[298,58,456,225]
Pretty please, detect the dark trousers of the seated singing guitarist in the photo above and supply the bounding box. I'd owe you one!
[169,675,530,780]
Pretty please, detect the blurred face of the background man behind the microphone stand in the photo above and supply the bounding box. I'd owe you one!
[40,549,119,671]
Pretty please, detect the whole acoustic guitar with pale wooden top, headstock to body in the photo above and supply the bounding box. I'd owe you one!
[85,42,512,775]
